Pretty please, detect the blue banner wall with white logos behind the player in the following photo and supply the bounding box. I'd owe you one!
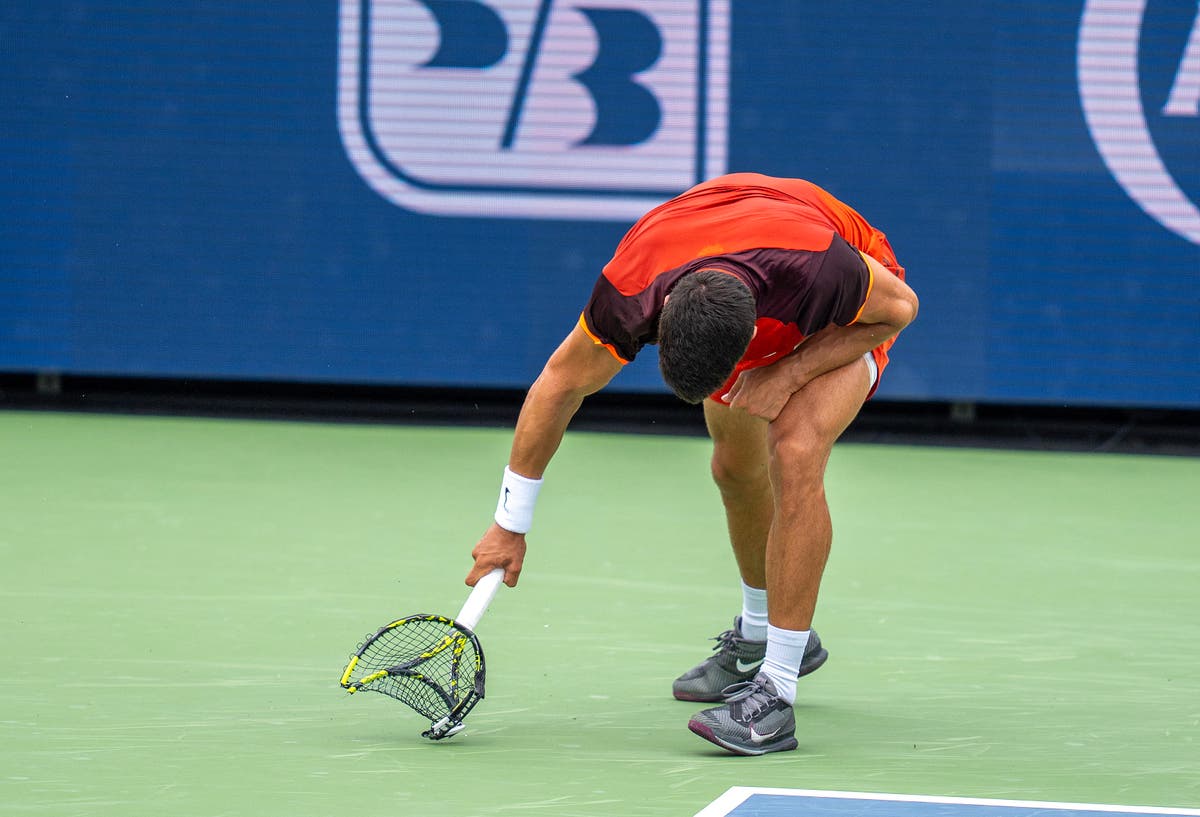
[0,0,1200,408]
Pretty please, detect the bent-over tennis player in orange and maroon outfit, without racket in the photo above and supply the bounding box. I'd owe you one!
[467,173,917,755]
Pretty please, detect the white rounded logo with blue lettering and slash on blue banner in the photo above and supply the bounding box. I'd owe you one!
[337,0,730,221]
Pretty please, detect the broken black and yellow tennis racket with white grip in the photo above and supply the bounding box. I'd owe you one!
[342,567,504,740]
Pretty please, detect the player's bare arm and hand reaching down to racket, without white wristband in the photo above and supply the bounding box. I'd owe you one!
[467,326,622,587]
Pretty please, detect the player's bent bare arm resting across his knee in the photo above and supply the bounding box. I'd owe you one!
[728,258,918,421]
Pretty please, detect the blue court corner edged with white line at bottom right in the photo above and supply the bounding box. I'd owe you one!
[696,787,1200,817]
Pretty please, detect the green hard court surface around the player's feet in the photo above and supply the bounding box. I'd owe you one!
[0,413,1200,817]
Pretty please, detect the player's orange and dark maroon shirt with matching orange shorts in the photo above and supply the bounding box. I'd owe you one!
[580,173,905,402]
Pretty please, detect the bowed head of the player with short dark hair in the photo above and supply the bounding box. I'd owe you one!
[659,270,757,403]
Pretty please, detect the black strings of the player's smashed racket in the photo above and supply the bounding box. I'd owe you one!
[350,617,482,721]
